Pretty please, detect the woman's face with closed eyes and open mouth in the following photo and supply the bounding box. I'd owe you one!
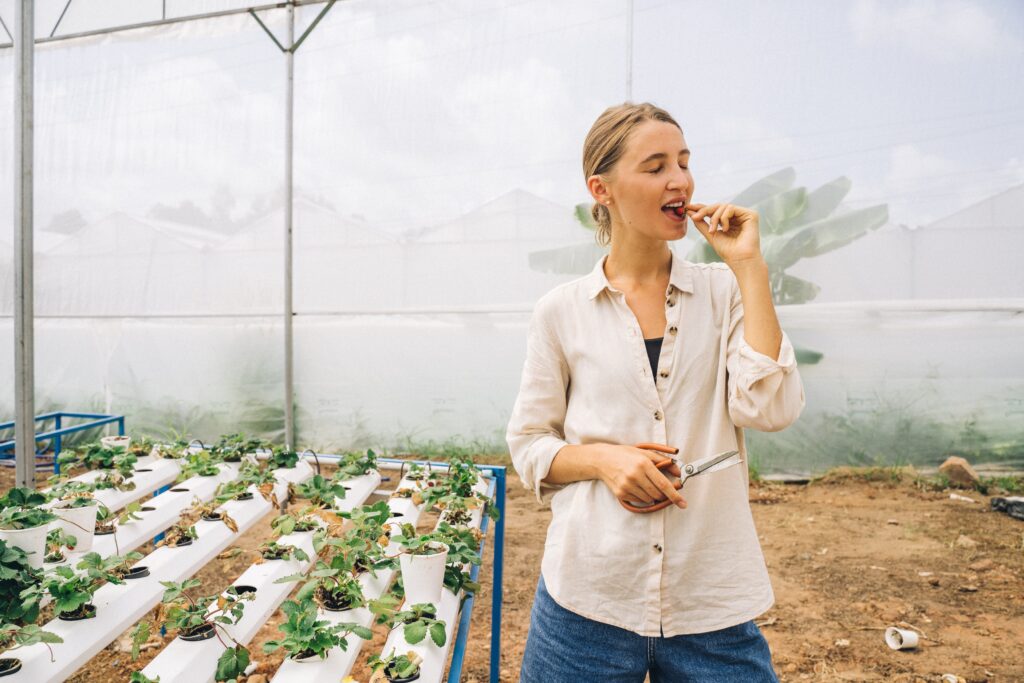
[588,121,693,241]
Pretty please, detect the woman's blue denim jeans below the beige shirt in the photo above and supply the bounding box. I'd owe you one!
[519,577,778,683]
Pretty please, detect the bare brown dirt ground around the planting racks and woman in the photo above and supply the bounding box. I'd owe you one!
[0,468,1024,683]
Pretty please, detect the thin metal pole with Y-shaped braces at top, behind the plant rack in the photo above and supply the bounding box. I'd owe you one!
[285,1,295,449]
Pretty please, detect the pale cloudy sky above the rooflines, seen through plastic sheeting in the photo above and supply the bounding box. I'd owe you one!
[0,0,1024,233]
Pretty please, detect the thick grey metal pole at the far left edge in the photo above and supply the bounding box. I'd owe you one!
[14,0,36,488]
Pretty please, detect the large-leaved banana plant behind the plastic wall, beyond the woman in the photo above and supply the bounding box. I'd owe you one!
[529,168,889,365]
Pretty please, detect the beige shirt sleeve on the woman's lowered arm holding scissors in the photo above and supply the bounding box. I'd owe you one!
[506,300,569,503]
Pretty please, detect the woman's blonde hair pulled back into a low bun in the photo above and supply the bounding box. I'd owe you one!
[583,102,682,245]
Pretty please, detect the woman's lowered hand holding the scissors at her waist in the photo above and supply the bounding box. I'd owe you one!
[595,443,686,508]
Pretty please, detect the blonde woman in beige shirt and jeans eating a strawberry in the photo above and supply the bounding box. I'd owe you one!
[508,103,804,683]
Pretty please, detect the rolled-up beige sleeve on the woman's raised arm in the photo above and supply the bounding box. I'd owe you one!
[726,288,805,431]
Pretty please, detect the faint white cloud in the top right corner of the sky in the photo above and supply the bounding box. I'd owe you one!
[849,0,1021,61]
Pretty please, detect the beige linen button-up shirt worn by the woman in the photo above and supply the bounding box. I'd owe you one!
[507,256,804,636]
